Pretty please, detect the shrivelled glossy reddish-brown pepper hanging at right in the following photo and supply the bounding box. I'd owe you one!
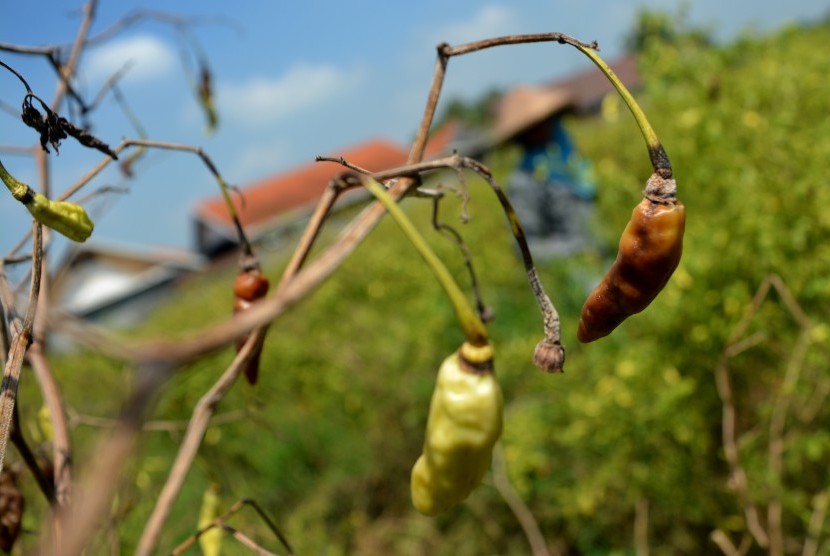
[577,195,686,343]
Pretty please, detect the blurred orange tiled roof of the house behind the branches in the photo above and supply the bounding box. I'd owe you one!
[196,139,408,236]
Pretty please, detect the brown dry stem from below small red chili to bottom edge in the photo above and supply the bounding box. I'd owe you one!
[136,328,265,555]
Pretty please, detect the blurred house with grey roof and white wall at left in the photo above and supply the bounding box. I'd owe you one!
[50,244,205,327]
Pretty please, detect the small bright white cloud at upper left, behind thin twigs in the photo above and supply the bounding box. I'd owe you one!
[83,35,176,82]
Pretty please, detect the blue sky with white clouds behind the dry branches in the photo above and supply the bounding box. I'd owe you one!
[0,0,830,253]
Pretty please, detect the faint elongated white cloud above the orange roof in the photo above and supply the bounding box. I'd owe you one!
[217,64,356,127]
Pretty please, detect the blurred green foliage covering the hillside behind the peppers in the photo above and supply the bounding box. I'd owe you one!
[16,14,830,556]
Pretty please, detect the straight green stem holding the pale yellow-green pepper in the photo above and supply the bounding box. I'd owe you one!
[363,178,488,346]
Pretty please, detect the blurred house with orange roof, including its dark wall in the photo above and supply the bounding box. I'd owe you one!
[193,139,416,257]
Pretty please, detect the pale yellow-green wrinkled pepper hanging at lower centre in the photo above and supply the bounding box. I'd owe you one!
[411,346,503,516]
